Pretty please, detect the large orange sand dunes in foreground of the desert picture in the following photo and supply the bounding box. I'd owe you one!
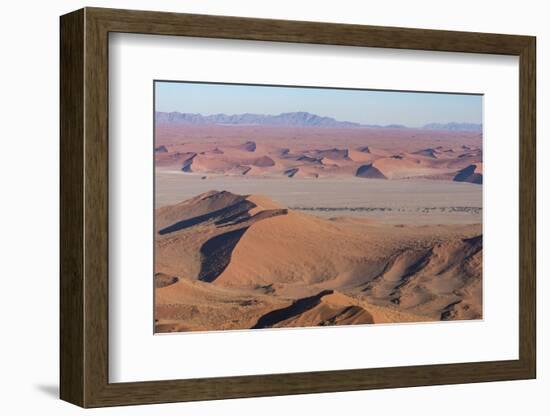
[155,191,482,332]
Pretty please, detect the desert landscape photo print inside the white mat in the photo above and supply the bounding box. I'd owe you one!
[153,81,483,333]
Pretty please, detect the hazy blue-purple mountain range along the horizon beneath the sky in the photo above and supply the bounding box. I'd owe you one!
[155,111,481,131]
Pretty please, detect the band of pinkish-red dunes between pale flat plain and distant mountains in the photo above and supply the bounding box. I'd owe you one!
[155,125,482,183]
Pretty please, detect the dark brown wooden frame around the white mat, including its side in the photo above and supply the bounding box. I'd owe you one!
[60,8,536,407]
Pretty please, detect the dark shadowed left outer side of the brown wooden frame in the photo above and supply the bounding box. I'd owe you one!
[59,9,85,406]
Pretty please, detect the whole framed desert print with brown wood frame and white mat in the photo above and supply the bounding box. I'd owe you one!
[60,8,536,407]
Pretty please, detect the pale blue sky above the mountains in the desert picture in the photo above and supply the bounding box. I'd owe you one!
[155,81,482,127]
